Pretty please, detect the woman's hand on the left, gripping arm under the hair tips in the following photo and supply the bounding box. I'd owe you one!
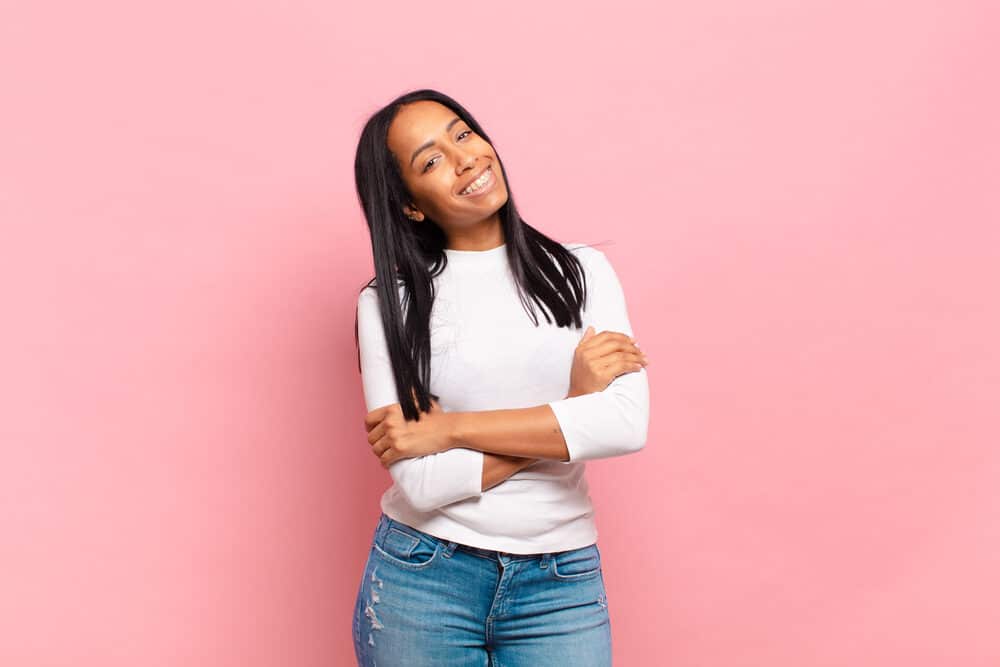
[365,399,451,468]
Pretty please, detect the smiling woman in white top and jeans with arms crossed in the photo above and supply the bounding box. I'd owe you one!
[353,90,649,667]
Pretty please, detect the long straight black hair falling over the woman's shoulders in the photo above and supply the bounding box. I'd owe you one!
[354,89,587,420]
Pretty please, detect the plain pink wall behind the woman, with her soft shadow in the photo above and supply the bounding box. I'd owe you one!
[0,0,1000,667]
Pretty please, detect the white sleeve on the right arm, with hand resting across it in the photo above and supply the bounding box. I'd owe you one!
[548,247,649,463]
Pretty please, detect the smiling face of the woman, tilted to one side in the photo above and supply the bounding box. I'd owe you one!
[388,100,507,238]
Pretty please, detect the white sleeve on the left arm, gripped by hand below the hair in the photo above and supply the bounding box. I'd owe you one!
[358,287,483,512]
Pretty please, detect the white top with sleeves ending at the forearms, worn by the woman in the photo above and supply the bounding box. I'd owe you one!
[358,243,649,554]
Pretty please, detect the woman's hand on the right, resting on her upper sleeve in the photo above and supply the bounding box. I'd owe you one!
[566,326,649,398]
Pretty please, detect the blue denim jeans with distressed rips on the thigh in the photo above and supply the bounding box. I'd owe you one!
[353,513,611,667]
